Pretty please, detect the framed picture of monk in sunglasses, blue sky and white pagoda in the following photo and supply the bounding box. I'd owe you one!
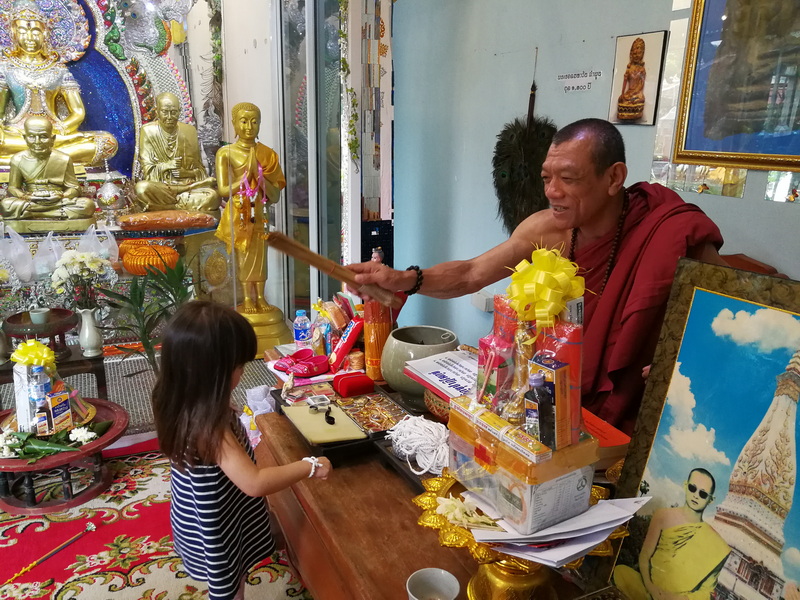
[612,259,800,600]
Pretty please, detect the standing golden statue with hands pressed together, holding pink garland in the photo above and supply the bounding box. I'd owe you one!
[216,102,292,354]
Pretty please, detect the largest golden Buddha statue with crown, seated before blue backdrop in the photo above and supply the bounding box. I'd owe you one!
[0,0,117,165]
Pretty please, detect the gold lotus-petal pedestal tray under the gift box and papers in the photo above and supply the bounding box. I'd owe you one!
[414,469,627,600]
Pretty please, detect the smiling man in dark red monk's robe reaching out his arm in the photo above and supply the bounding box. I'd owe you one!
[350,119,724,433]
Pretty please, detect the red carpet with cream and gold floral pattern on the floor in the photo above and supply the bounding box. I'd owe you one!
[0,452,310,600]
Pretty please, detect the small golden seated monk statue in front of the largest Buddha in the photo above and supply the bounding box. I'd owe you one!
[0,117,95,233]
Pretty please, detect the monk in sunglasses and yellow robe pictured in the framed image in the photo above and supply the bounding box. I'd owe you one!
[614,468,731,600]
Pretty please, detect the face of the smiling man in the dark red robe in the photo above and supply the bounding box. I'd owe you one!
[542,134,618,229]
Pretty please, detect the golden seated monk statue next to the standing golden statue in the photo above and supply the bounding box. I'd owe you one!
[136,92,219,216]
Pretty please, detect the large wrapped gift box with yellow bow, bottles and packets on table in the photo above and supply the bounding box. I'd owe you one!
[449,249,598,534]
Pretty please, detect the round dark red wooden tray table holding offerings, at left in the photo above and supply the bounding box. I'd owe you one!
[0,398,128,515]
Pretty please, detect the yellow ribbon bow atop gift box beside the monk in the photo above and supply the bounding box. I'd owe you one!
[507,248,584,327]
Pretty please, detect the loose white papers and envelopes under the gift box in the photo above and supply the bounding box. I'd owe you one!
[463,492,650,568]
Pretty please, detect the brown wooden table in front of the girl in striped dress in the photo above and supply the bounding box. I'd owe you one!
[256,413,477,600]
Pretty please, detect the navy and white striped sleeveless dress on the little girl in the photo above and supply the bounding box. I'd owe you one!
[170,420,275,600]
